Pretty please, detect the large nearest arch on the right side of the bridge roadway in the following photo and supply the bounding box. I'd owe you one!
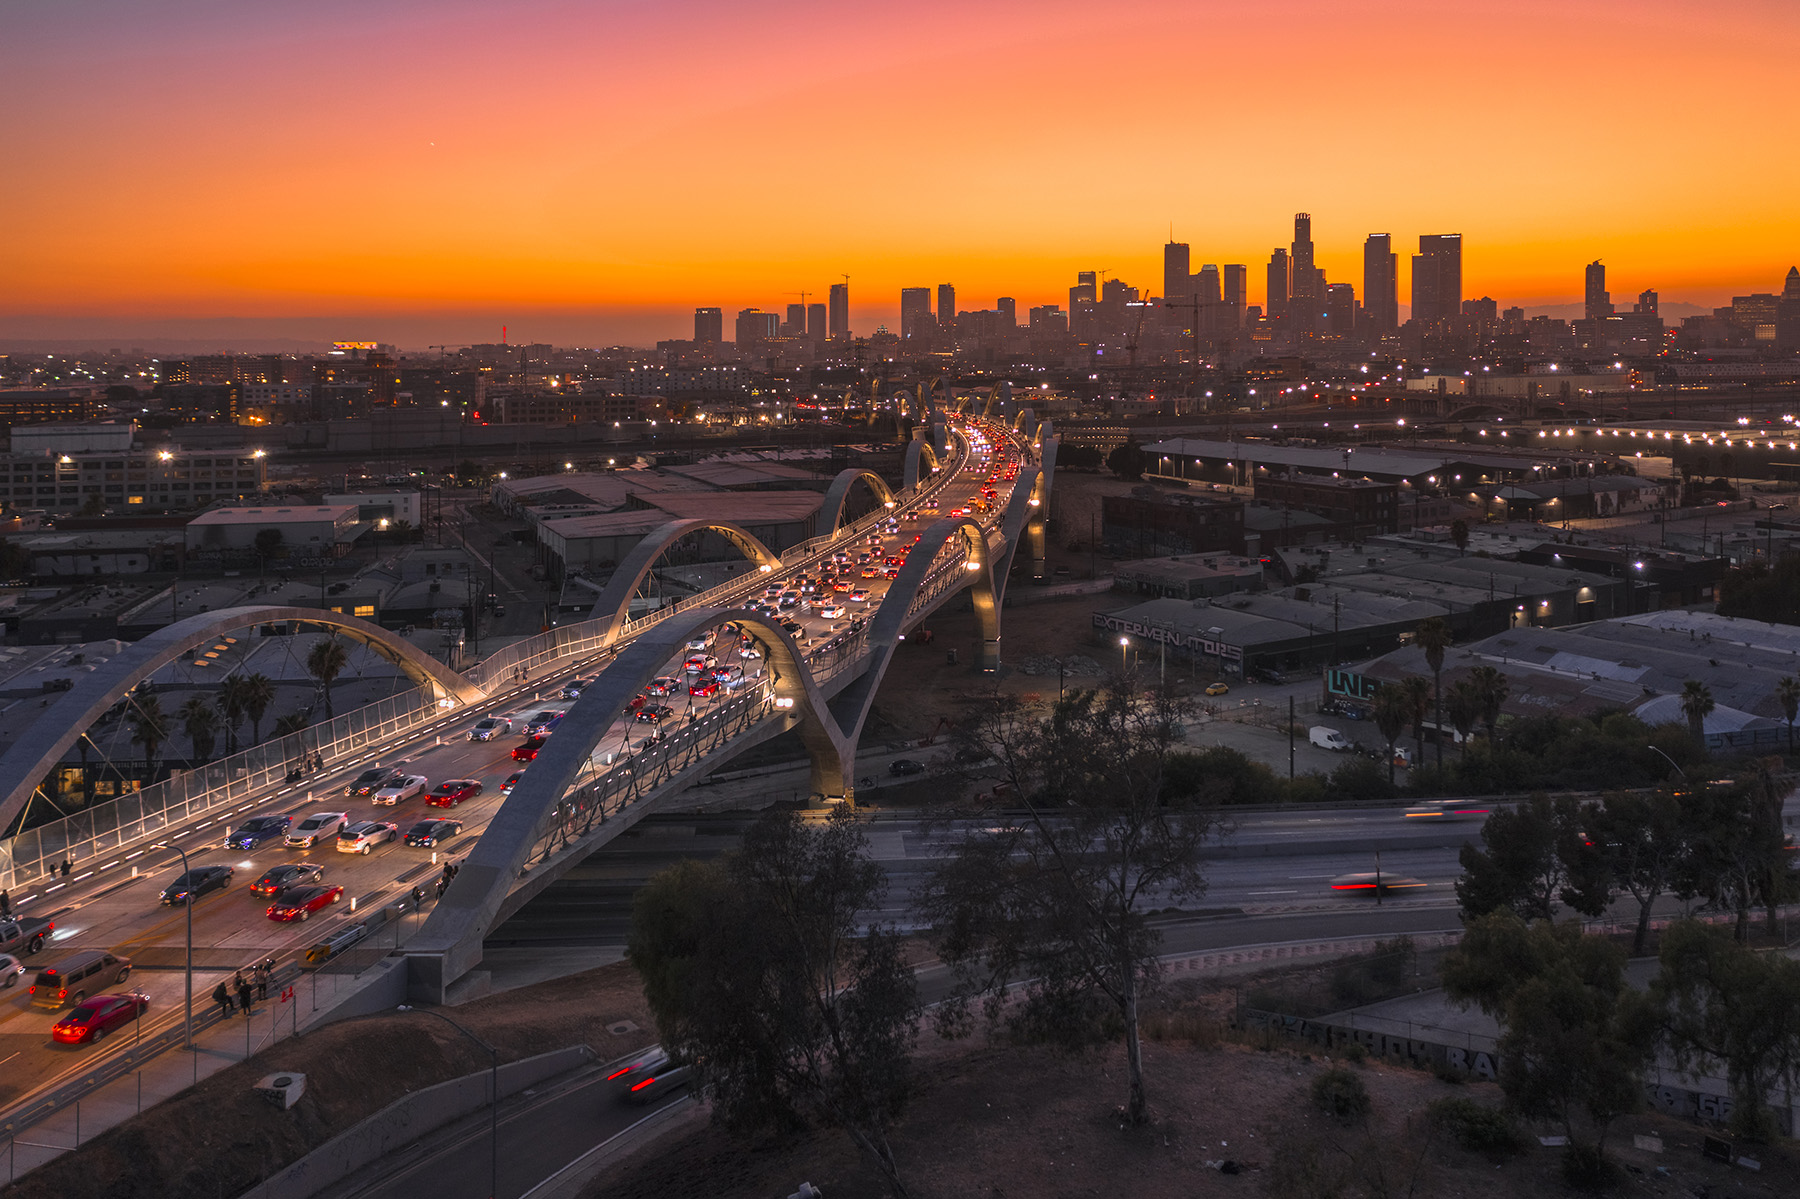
[407,607,853,1001]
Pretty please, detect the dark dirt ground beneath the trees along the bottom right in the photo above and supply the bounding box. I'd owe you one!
[583,1015,1800,1199]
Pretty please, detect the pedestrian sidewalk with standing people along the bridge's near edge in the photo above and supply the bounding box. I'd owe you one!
[0,950,397,1185]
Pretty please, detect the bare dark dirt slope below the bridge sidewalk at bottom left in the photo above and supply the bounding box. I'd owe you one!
[7,965,655,1199]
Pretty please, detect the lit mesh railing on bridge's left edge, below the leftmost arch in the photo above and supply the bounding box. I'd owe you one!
[0,691,443,898]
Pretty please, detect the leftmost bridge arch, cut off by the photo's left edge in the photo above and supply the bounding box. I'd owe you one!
[0,605,482,828]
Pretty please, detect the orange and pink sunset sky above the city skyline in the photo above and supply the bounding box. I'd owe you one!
[0,0,1800,346]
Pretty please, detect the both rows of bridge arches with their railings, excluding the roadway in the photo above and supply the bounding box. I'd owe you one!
[0,410,1057,999]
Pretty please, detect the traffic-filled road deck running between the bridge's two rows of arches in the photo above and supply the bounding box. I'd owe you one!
[0,417,1019,1104]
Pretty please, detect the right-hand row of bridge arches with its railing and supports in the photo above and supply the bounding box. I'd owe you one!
[407,414,1057,1001]
